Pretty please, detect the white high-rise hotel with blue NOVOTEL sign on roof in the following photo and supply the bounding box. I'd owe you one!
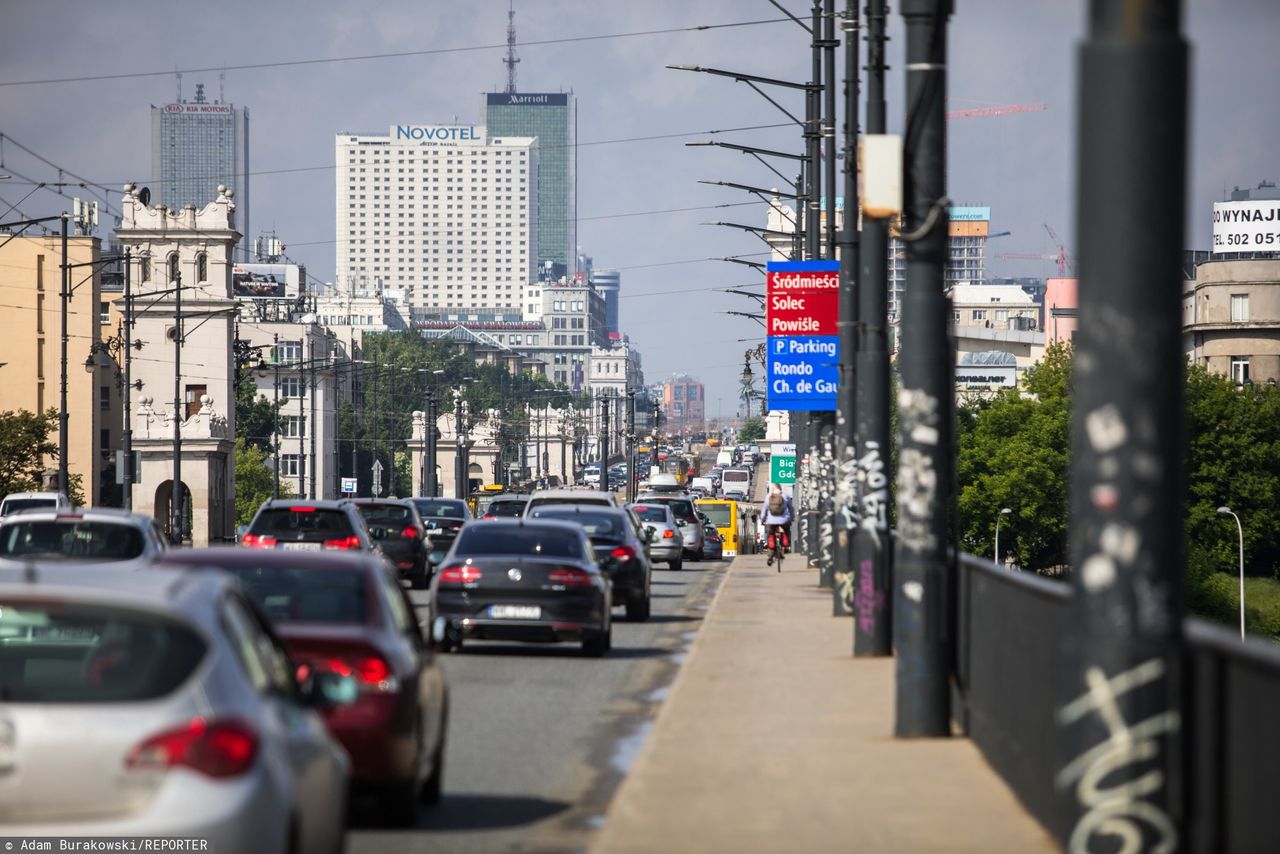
[335,124,538,319]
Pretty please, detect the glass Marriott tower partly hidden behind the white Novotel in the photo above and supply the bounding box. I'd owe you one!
[485,92,577,279]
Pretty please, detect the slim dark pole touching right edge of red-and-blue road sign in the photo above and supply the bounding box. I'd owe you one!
[829,0,860,617]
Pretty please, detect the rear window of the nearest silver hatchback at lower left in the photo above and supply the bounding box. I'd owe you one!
[0,600,205,703]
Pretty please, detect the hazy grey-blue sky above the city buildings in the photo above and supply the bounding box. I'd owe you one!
[0,0,1280,416]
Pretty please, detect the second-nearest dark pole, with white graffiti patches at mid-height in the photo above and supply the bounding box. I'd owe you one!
[893,0,954,737]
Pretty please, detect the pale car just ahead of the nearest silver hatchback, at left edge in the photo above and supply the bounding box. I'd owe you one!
[0,507,168,568]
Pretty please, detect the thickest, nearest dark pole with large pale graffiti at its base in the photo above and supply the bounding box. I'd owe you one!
[1056,0,1188,850]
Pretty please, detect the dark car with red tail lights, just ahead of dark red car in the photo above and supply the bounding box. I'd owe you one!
[241,498,379,552]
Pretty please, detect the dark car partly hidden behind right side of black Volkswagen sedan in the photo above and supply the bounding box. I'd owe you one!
[527,504,653,622]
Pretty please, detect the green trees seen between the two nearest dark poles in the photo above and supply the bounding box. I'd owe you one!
[956,343,1071,570]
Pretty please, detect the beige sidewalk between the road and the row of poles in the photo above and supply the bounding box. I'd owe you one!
[591,554,1057,854]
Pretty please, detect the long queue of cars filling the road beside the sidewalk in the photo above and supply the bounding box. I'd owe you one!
[0,442,762,851]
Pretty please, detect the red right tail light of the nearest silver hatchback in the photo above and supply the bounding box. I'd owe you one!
[124,717,257,778]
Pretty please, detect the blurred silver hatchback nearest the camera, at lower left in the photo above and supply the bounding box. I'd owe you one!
[0,565,356,851]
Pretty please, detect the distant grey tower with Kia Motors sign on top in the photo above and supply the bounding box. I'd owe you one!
[150,83,250,261]
